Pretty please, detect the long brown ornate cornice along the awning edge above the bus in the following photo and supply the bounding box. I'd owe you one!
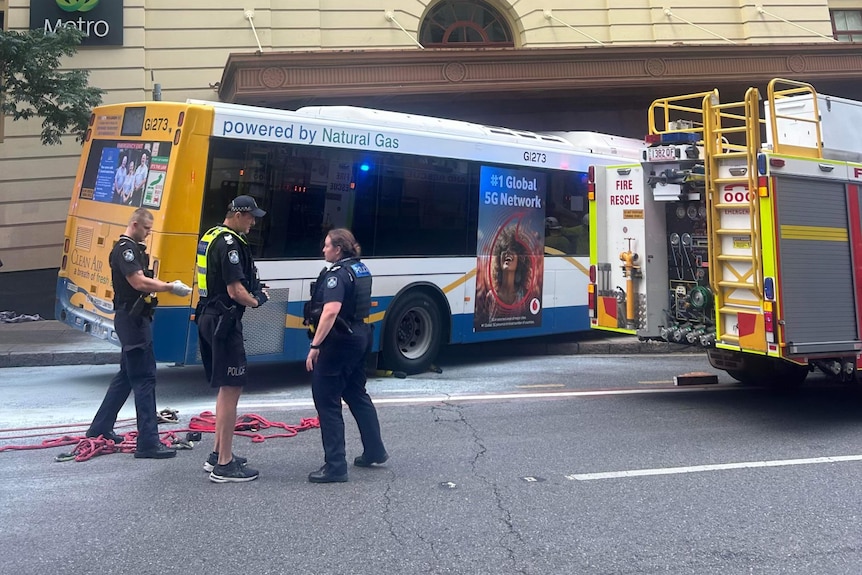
[219,43,862,104]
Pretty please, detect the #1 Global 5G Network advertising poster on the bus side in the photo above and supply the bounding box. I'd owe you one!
[473,166,547,331]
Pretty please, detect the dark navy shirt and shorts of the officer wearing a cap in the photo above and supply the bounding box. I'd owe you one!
[196,229,260,387]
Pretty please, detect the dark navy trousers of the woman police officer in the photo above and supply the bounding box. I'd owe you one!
[311,324,386,475]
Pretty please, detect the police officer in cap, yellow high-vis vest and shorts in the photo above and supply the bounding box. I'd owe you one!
[195,196,269,483]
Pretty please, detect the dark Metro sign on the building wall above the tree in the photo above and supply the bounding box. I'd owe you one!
[30,0,123,46]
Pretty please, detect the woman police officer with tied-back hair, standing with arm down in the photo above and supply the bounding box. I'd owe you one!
[305,228,389,483]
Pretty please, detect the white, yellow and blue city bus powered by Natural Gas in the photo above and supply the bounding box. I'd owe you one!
[56,100,640,373]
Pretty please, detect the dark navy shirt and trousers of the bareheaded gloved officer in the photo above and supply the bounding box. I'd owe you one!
[87,235,159,451]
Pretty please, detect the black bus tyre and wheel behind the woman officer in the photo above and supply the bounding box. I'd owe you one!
[381,292,443,375]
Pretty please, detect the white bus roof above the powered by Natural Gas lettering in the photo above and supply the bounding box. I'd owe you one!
[187,99,643,159]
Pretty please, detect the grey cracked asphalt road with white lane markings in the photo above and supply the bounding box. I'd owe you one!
[0,355,862,575]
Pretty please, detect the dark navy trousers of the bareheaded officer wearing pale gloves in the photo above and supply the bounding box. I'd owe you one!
[87,309,159,450]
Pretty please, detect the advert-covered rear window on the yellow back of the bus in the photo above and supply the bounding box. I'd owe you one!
[80,140,171,210]
